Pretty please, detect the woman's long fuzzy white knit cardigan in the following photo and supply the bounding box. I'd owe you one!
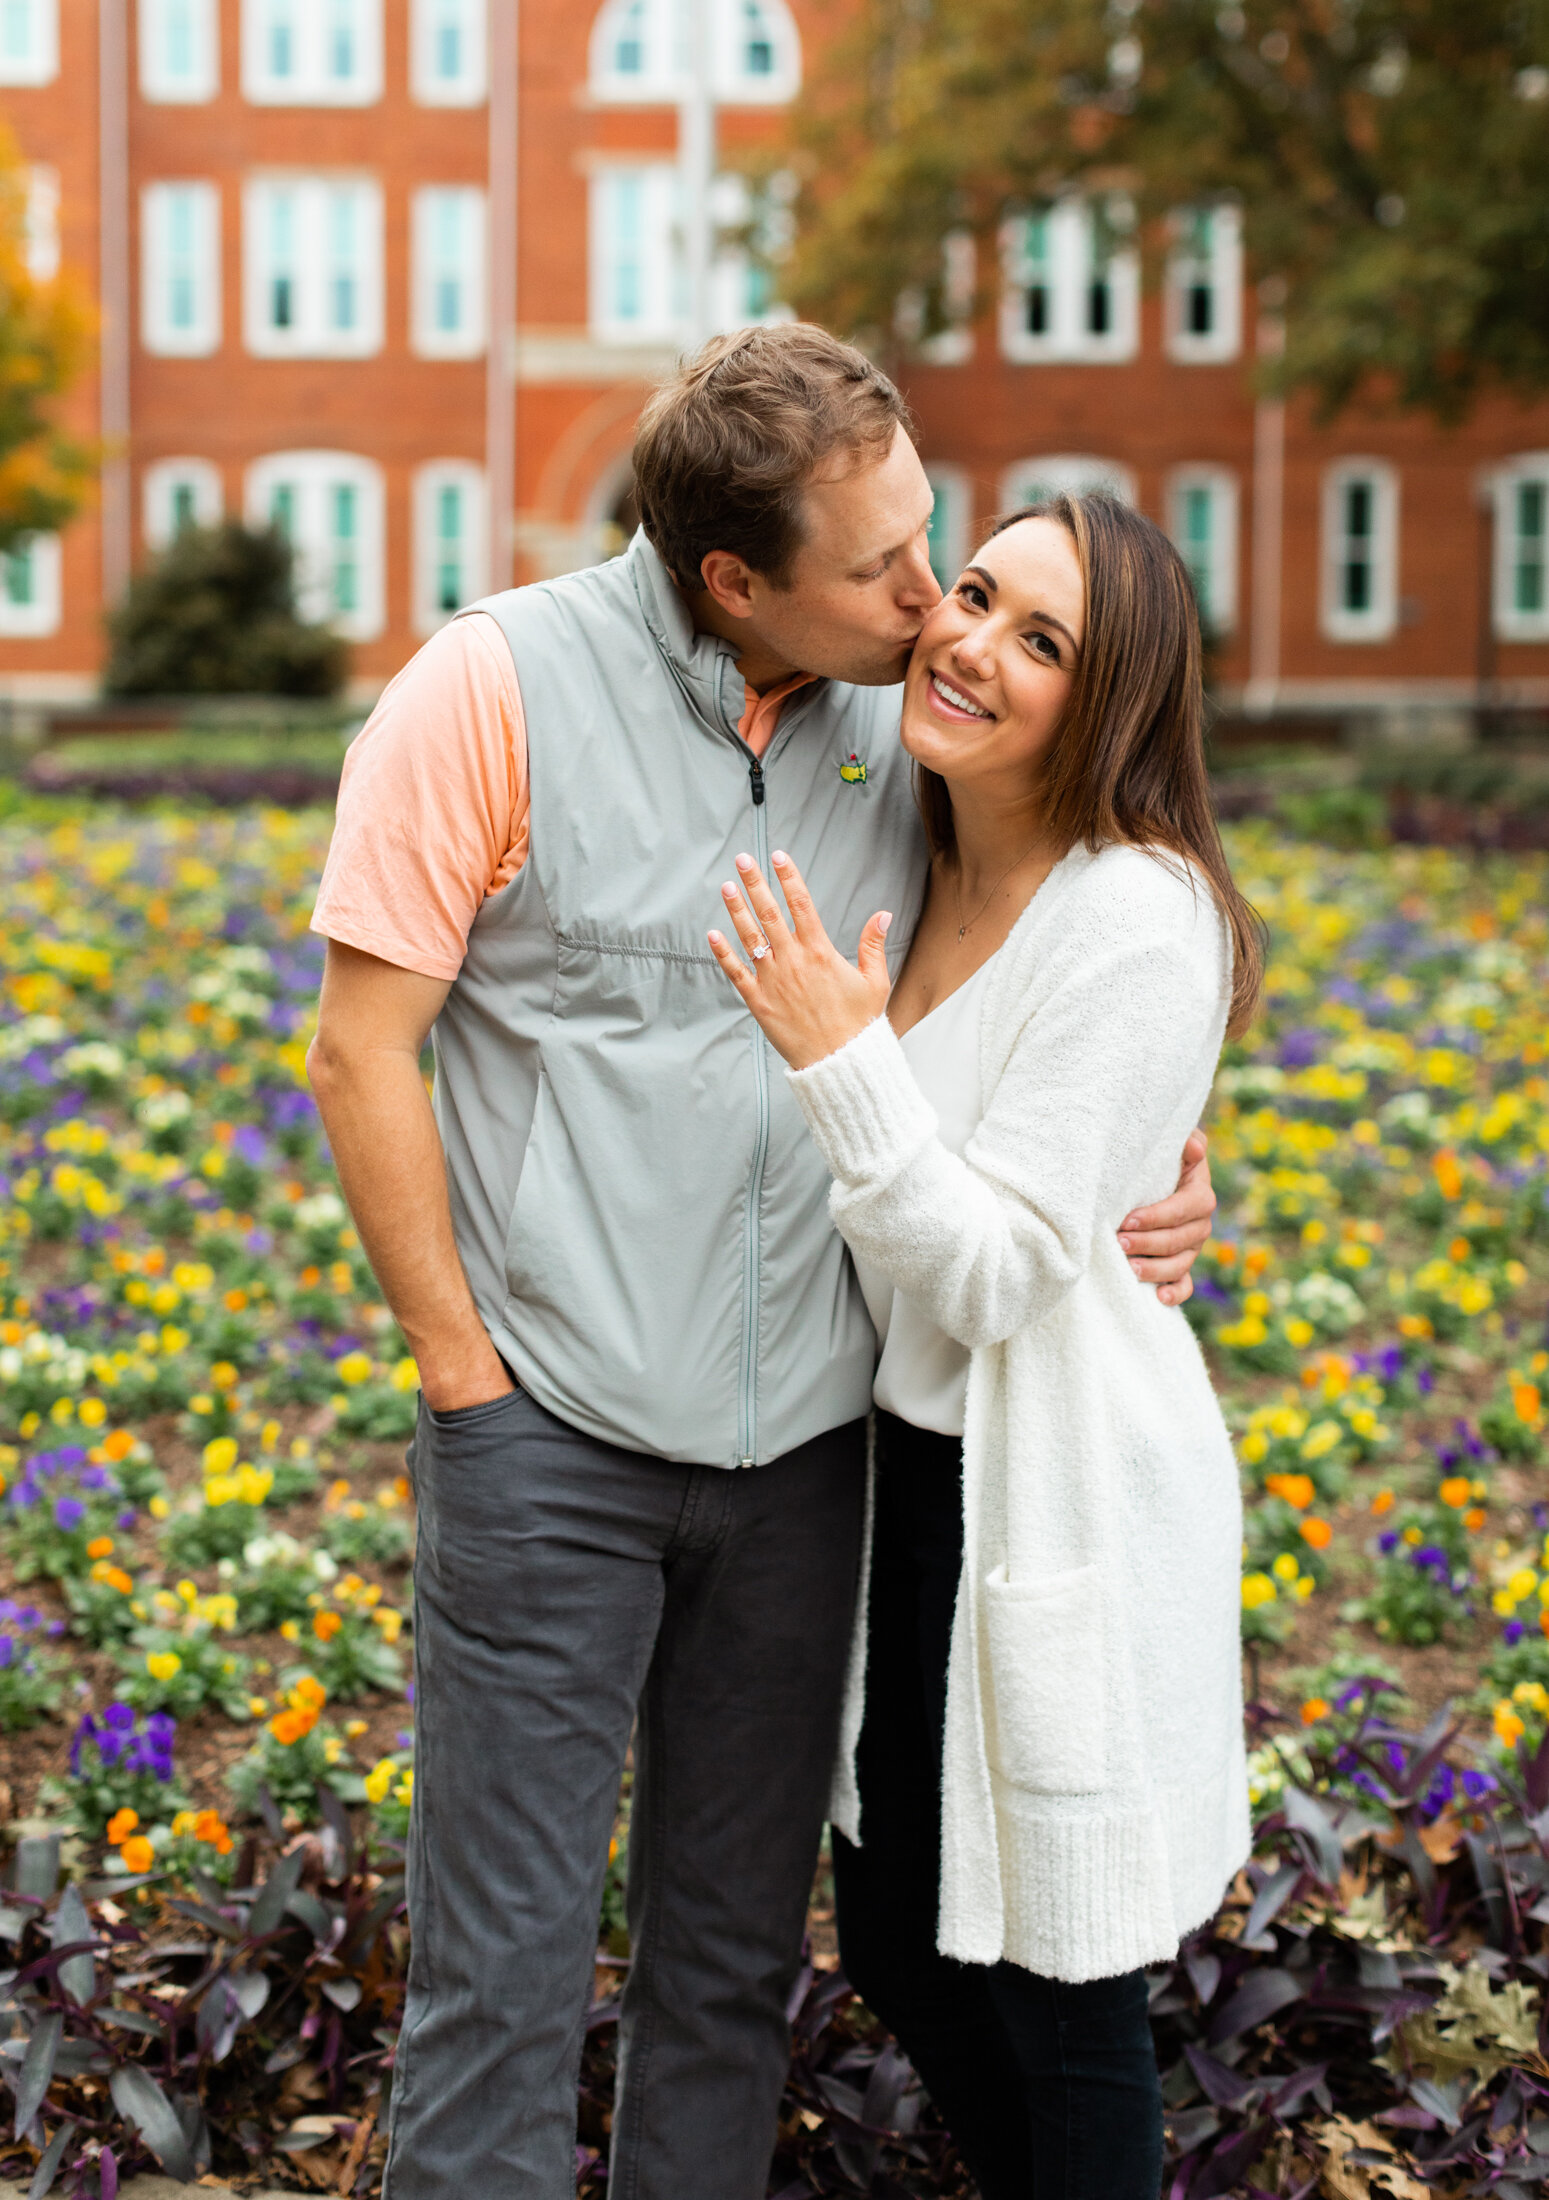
[790,847,1250,1980]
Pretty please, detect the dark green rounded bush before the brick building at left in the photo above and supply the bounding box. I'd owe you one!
[103,521,345,695]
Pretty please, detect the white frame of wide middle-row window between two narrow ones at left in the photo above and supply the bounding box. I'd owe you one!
[242,169,383,359]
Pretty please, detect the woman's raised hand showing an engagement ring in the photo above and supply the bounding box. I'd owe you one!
[711,849,893,1069]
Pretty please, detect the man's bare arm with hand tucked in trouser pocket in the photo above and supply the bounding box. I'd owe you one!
[306,939,510,1412]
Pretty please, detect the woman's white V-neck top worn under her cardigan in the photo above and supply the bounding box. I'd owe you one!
[856,948,999,1437]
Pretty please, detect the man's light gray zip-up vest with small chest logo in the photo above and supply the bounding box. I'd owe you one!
[433,535,924,1467]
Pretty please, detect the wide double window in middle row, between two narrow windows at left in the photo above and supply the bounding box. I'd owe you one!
[244,176,383,359]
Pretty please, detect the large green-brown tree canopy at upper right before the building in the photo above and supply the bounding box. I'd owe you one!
[786,0,1549,418]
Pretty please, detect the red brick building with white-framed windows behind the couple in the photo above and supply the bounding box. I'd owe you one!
[0,0,1549,713]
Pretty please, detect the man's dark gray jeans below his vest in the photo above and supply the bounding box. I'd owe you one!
[383,1390,865,2200]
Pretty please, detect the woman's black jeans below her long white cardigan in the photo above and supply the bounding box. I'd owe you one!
[834,1412,1162,2200]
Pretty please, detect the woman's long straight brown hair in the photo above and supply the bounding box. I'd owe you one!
[915,495,1263,1038]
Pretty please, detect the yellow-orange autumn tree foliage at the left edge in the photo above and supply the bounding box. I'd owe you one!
[0,132,97,552]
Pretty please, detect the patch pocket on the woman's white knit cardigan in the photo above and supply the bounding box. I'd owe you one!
[984,1566,1109,1795]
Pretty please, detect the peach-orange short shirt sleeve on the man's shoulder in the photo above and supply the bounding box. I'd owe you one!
[312,616,528,979]
